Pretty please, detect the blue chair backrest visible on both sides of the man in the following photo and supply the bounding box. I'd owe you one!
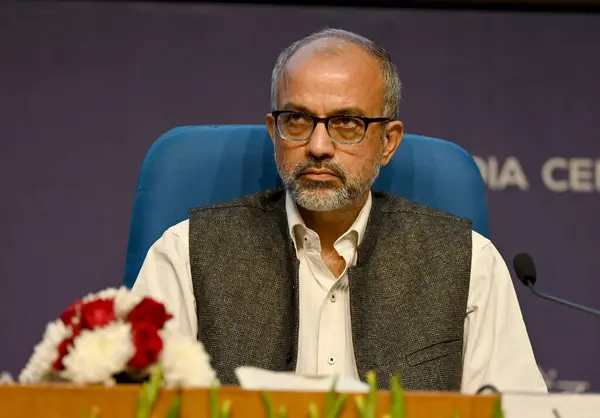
[124,125,488,286]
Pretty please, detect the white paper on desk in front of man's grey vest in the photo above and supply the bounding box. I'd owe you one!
[235,367,369,393]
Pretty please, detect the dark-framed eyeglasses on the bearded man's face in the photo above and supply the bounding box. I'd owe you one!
[271,110,393,144]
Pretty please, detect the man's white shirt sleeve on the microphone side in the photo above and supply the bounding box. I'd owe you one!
[461,233,547,393]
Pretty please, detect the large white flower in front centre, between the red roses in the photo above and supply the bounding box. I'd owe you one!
[60,321,135,385]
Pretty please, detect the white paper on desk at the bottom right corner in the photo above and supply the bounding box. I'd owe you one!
[502,393,600,418]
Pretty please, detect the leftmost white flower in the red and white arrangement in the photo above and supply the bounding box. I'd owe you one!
[19,319,71,384]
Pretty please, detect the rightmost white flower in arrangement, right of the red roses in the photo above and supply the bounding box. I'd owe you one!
[159,331,219,387]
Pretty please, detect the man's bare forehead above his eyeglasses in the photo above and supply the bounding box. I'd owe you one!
[279,39,383,113]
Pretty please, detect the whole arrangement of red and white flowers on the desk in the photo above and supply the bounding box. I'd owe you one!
[19,287,218,387]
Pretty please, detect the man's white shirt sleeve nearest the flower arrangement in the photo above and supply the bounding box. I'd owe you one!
[132,221,198,338]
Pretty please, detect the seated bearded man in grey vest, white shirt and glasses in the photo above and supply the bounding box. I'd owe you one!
[134,29,546,393]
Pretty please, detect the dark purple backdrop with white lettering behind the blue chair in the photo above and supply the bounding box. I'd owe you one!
[0,2,600,390]
